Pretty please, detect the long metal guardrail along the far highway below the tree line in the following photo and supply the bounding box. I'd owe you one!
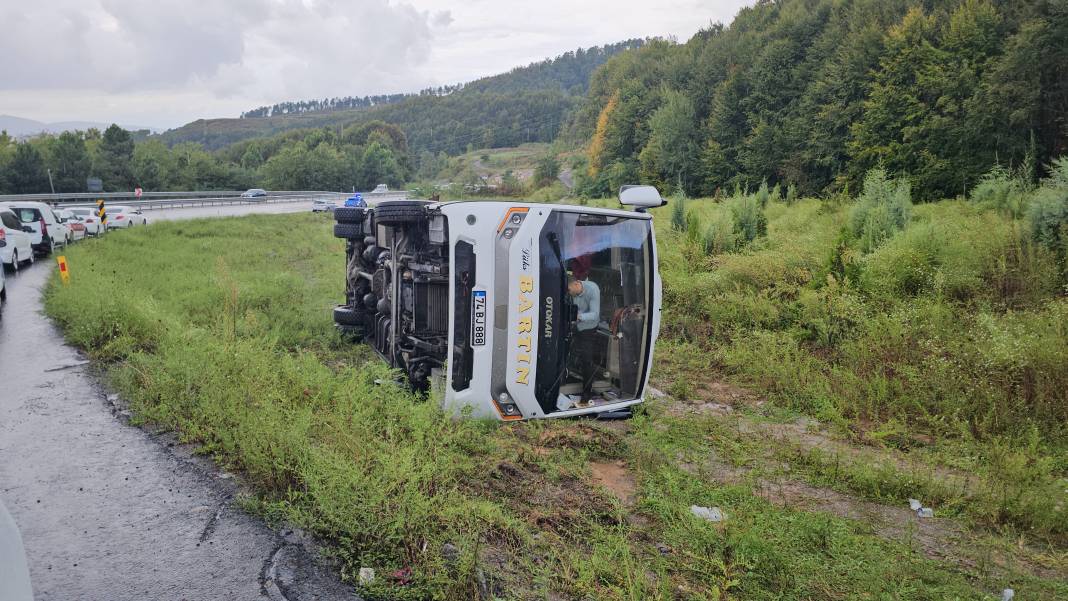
[0,190,408,210]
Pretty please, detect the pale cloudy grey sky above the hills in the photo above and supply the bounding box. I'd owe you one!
[0,0,753,129]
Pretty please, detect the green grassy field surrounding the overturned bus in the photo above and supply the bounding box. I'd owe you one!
[46,200,1068,600]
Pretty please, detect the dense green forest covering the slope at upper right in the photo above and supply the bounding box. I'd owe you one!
[567,0,1068,199]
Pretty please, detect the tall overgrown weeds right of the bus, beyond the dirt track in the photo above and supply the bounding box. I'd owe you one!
[645,173,1068,539]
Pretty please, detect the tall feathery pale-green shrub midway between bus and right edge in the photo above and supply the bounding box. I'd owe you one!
[849,169,912,253]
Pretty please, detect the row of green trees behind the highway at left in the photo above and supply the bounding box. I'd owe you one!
[0,122,411,194]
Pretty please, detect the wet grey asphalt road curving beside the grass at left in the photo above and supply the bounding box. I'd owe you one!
[0,205,355,601]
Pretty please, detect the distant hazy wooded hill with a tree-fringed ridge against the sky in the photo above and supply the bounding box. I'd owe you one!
[160,39,643,153]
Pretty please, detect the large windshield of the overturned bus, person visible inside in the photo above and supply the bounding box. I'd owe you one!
[535,210,651,412]
